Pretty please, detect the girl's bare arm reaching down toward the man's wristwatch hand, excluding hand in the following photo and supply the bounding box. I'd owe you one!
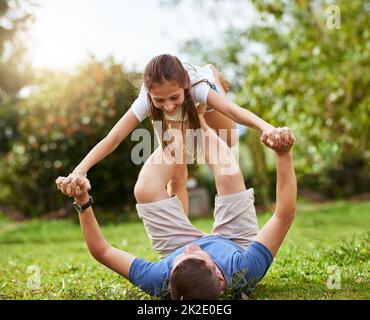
[73,110,139,173]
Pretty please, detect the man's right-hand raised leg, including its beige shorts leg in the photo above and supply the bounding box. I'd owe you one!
[202,116,258,249]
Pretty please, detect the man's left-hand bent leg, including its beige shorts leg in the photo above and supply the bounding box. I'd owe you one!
[135,137,204,258]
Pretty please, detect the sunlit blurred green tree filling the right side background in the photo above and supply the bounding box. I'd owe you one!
[178,0,370,196]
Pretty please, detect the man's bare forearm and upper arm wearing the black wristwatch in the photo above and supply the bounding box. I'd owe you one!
[75,192,136,279]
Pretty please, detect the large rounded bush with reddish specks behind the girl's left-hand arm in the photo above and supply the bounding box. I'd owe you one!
[0,58,149,215]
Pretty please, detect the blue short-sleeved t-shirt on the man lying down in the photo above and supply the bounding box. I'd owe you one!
[129,235,273,295]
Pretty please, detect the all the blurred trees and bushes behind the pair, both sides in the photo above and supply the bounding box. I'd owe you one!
[0,0,370,216]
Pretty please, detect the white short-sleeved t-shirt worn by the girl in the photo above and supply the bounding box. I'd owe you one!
[131,65,216,122]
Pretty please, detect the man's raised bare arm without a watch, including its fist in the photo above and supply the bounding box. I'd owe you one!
[255,130,297,256]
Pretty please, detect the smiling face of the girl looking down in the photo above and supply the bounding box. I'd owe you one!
[149,81,185,115]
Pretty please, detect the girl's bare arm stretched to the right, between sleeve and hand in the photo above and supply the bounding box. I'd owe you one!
[207,90,275,131]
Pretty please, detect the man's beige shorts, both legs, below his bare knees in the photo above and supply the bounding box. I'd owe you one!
[136,188,258,258]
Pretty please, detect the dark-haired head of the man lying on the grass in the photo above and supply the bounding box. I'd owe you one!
[169,244,226,300]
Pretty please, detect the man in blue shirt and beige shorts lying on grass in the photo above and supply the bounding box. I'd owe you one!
[56,121,297,299]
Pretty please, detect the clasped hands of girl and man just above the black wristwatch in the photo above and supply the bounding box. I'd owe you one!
[55,173,91,197]
